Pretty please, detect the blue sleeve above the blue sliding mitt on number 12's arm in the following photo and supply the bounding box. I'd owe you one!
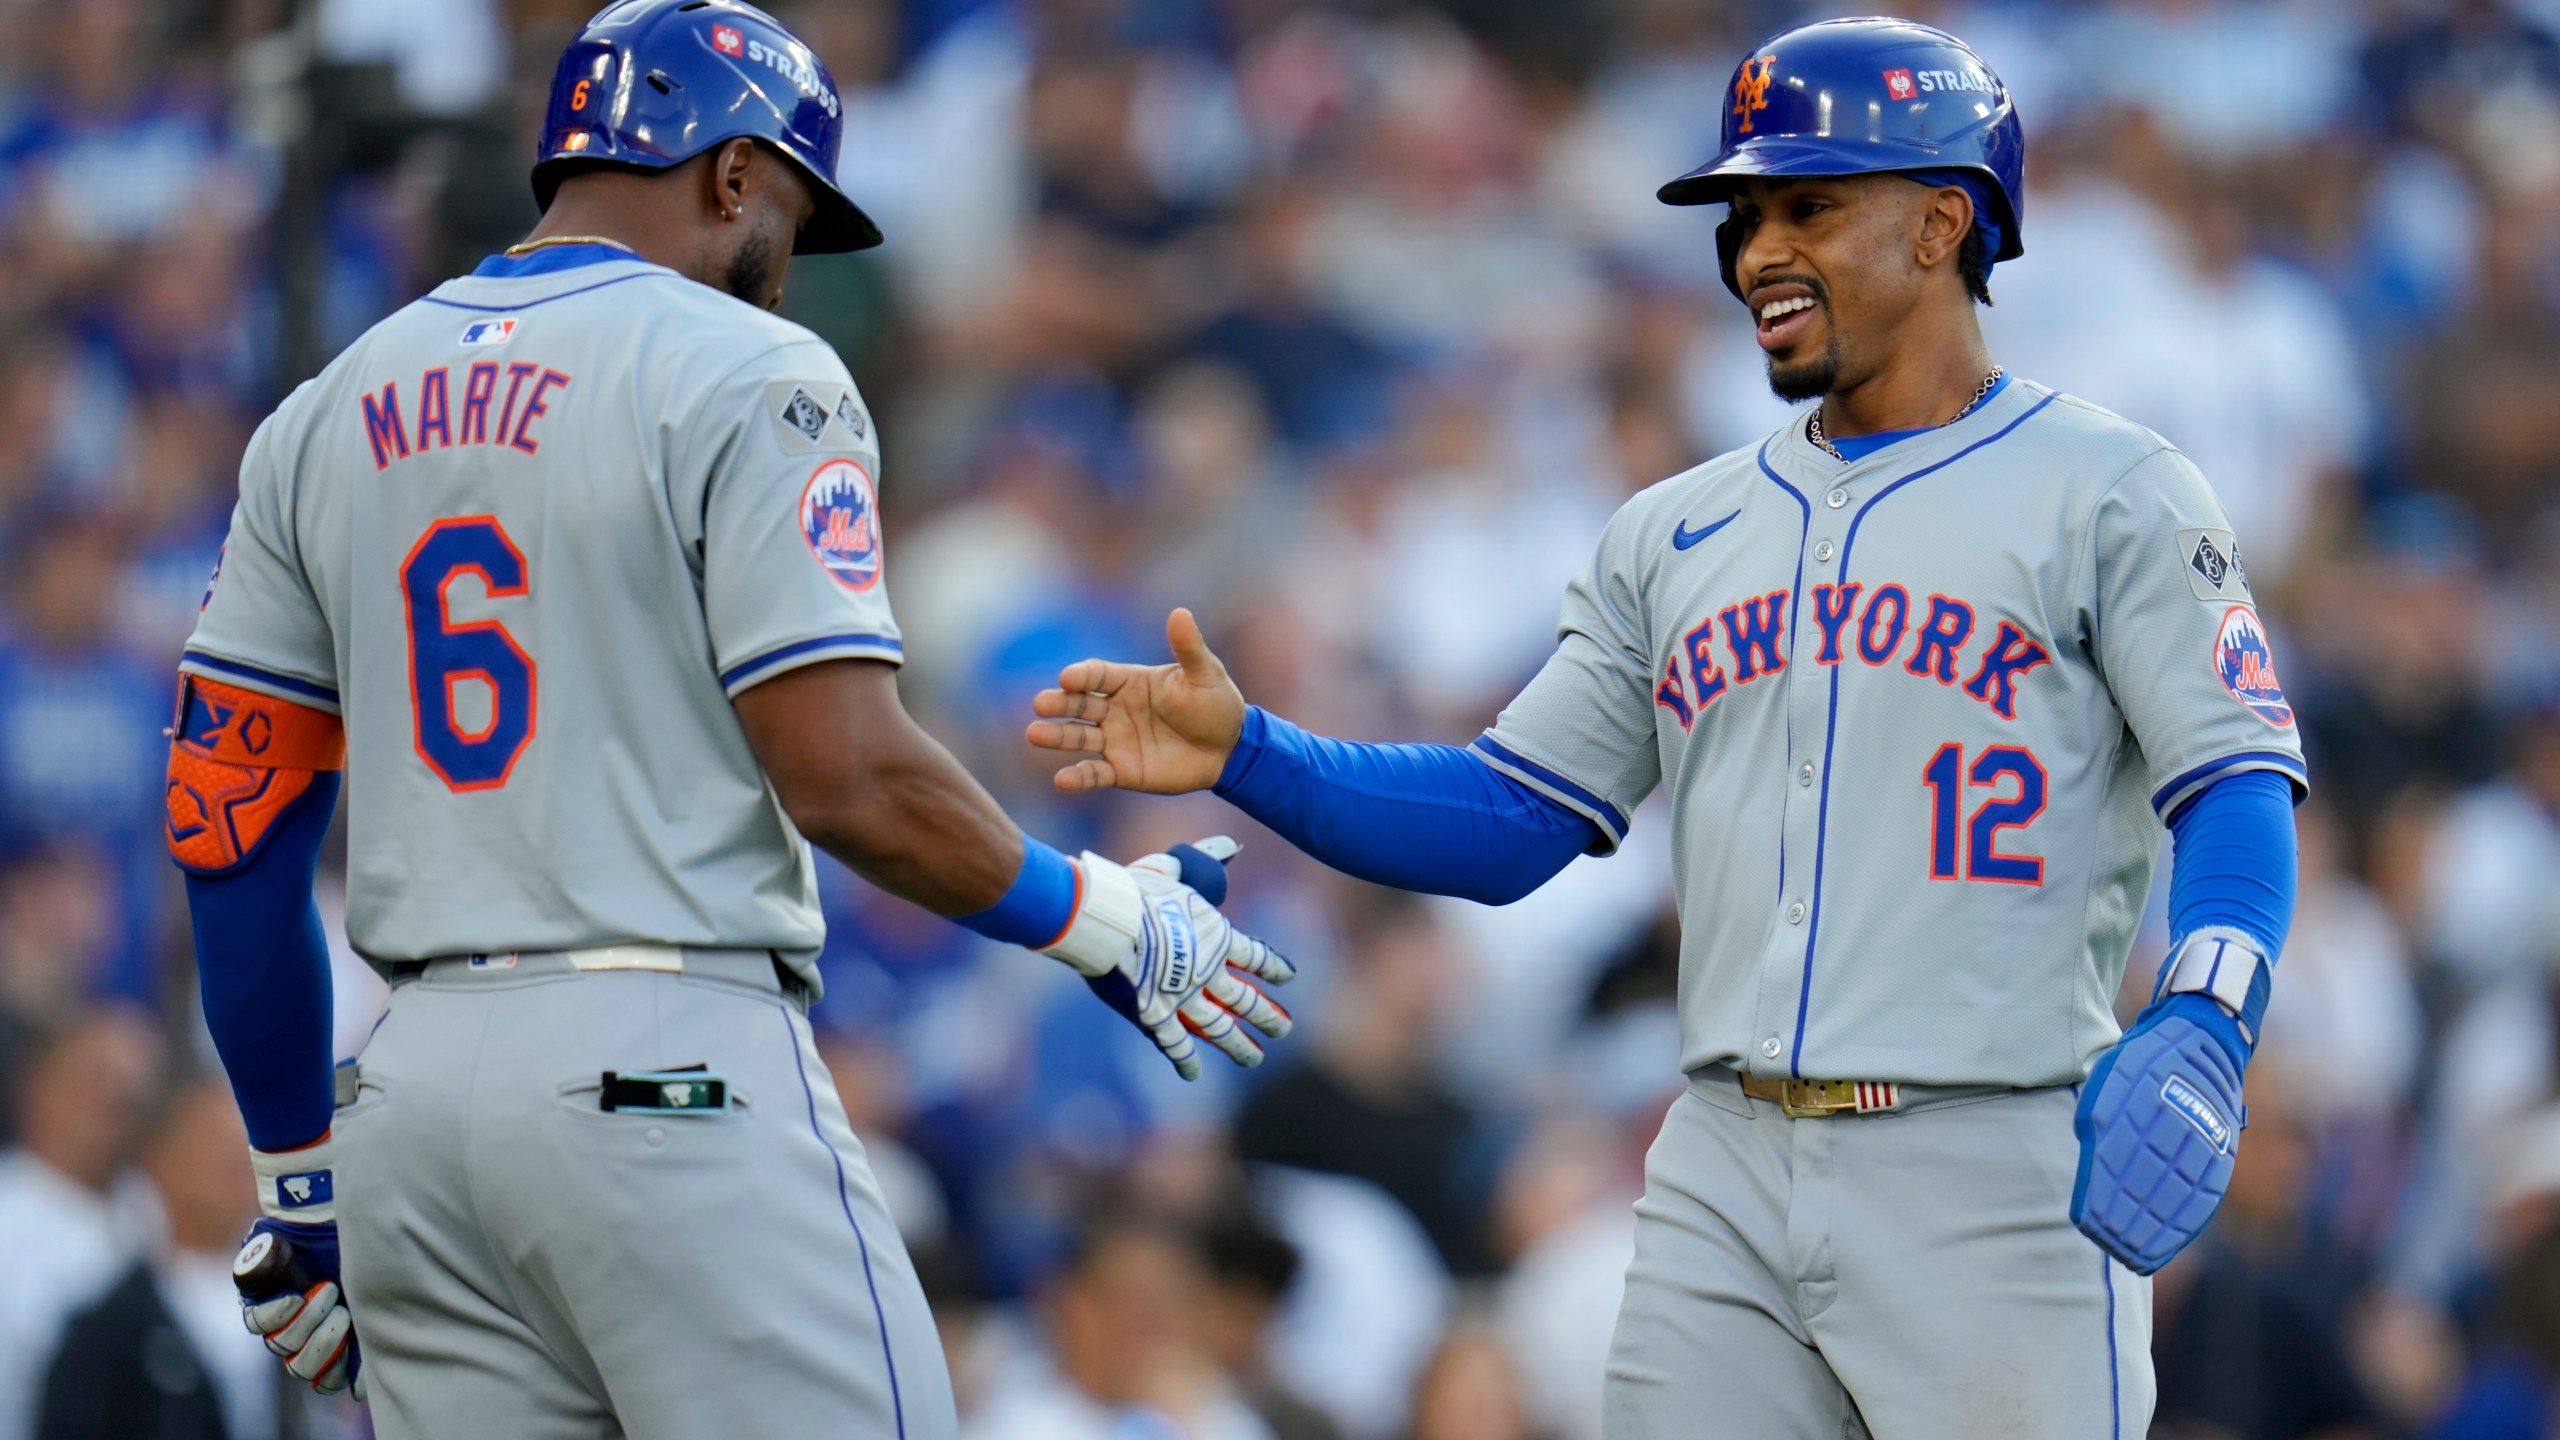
[2168,771,2296,961]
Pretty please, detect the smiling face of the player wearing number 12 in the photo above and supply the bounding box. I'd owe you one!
[1733,174,1974,400]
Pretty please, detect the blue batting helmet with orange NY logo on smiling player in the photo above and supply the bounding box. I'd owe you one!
[1659,15,2028,287]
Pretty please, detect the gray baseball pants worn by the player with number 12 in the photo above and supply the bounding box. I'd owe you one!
[1603,1066,2153,1440]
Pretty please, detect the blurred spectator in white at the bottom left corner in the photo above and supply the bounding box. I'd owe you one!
[0,1010,165,1440]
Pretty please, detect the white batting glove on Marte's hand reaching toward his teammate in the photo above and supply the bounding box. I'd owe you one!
[1042,835,1298,1079]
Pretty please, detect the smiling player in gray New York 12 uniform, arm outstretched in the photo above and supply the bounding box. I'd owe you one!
[1029,20,2304,1440]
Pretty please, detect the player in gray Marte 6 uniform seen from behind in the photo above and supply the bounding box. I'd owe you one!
[149,0,1290,1440]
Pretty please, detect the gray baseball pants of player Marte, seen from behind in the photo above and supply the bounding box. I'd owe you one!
[335,951,957,1440]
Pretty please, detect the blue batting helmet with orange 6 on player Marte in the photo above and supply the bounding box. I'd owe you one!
[532,0,881,254]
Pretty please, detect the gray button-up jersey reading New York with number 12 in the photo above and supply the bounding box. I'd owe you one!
[1475,379,2304,1086]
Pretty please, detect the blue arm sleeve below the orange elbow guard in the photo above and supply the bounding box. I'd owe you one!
[187,774,338,1150]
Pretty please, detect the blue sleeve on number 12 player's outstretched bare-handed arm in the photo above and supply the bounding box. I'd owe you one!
[1219,705,1605,904]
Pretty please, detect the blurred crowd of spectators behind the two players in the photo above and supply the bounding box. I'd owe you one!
[0,0,2560,1440]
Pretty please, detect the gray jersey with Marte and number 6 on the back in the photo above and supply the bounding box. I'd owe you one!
[184,246,899,961]
